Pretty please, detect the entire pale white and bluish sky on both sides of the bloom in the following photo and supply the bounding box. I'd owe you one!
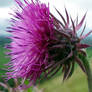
[0,0,92,35]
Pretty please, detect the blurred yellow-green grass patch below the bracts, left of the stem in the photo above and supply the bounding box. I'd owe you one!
[39,64,88,92]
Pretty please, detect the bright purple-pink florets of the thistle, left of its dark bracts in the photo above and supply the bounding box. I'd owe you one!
[7,0,54,87]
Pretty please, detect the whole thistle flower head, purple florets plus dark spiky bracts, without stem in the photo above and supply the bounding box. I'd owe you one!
[7,0,92,88]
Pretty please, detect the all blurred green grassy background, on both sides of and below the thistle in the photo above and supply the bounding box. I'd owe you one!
[0,46,92,92]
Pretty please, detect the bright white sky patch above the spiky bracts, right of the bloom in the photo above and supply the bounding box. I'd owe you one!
[43,0,92,29]
